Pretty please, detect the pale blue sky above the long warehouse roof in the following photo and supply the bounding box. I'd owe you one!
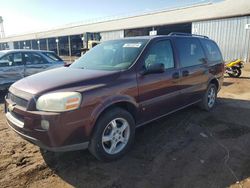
[0,0,216,36]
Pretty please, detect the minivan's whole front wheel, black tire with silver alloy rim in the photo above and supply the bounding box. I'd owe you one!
[89,108,135,161]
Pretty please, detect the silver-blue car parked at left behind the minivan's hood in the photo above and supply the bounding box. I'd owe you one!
[0,50,65,90]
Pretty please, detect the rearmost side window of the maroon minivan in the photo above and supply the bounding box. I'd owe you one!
[202,40,222,62]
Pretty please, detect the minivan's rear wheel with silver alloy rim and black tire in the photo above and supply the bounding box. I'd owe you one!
[200,84,218,111]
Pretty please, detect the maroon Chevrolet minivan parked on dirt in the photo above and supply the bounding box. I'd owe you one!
[5,33,224,161]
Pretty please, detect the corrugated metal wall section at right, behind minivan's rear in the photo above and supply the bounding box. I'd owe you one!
[192,16,250,61]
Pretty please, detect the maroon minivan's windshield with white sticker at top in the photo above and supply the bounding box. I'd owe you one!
[70,39,148,71]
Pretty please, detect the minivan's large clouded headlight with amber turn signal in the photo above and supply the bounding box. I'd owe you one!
[36,92,82,112]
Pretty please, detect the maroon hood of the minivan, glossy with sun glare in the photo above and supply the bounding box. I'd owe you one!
[10,67,119,95]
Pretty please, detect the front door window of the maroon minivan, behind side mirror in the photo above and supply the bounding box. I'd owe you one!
[144,40,174,69]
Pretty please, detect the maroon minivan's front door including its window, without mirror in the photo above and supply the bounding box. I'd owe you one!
[137,40,181,123]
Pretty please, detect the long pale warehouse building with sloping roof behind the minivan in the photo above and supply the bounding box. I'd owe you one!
[0,0,250,61]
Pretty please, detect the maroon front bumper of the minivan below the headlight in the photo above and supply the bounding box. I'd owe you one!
[5,99,89,152]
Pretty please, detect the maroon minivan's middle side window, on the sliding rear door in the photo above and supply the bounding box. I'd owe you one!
[176,38,205,67]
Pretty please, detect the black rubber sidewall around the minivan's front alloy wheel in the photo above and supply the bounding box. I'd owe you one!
[89,108,135,161]
